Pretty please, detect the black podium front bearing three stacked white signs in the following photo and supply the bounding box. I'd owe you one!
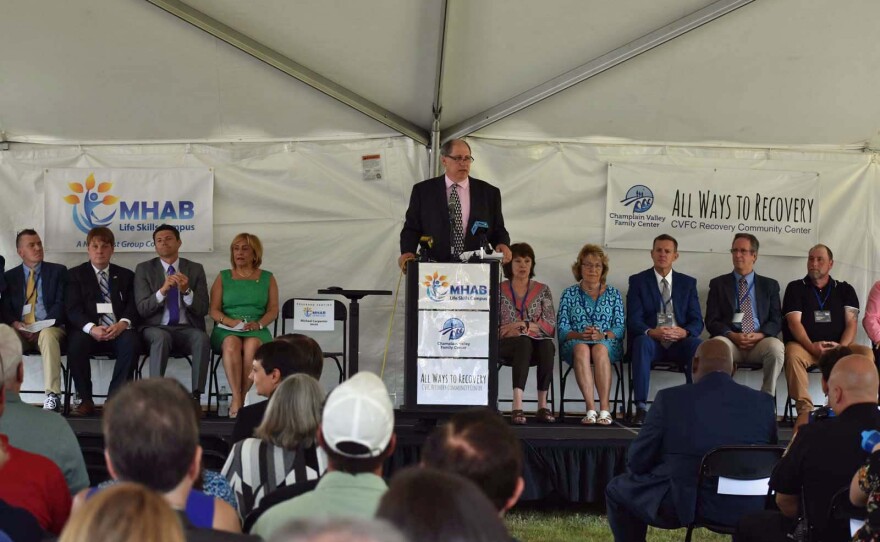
[405,261,498,411]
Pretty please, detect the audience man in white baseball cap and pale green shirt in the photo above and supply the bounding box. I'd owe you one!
[251,371,397,539]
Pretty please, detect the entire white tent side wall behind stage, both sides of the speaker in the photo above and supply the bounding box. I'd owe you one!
[0,137,880,416]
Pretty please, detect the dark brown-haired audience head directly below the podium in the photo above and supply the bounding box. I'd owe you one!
[422,408,524,512]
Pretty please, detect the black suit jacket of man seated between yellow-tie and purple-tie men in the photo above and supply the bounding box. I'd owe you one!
[65,262,138,330]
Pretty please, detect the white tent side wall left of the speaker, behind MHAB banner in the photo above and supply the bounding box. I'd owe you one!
[0,137,427,406]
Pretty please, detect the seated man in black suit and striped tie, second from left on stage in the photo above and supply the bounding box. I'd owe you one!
[66,227,140,416]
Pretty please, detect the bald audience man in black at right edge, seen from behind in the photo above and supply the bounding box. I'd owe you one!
[738,354,880,542]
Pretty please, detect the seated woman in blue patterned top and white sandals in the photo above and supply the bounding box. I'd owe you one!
[556,244,626,425]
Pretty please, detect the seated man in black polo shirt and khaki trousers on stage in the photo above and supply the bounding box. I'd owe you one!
[782,244,873,428]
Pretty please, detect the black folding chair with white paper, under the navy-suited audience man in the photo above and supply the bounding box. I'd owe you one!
[685,445,785,542]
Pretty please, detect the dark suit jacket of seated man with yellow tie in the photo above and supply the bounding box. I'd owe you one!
[0,262,68,326]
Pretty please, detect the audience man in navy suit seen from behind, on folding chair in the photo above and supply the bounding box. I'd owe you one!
[605,339,776,542]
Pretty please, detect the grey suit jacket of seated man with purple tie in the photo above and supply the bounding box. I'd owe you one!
[134,258,208,331]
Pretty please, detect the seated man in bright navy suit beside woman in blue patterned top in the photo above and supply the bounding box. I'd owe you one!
[626,234,703,425]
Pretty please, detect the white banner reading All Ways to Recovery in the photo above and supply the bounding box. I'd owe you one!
[605,163,819,256]
